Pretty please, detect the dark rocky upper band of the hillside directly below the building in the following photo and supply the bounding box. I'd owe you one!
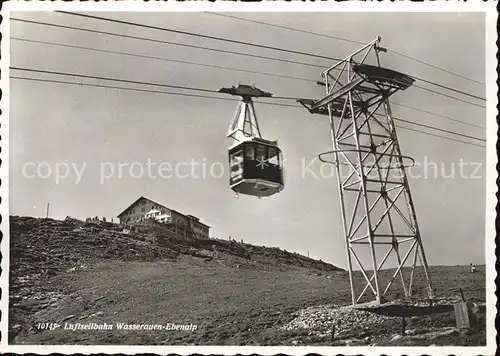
[10,216,341,288]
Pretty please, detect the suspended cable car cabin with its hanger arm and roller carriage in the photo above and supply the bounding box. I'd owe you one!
[219,84,284,198]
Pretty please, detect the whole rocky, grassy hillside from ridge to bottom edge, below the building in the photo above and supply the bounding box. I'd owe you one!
[8,216,486,346]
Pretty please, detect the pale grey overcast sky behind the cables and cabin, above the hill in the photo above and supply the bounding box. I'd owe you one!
[10,12,486,268]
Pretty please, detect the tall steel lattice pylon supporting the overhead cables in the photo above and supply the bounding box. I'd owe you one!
[299,37,434,304]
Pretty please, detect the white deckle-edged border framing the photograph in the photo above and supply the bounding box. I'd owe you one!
[0,1,498,356]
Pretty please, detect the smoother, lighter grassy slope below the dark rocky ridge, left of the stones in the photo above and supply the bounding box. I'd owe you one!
[17,260,345,344]
